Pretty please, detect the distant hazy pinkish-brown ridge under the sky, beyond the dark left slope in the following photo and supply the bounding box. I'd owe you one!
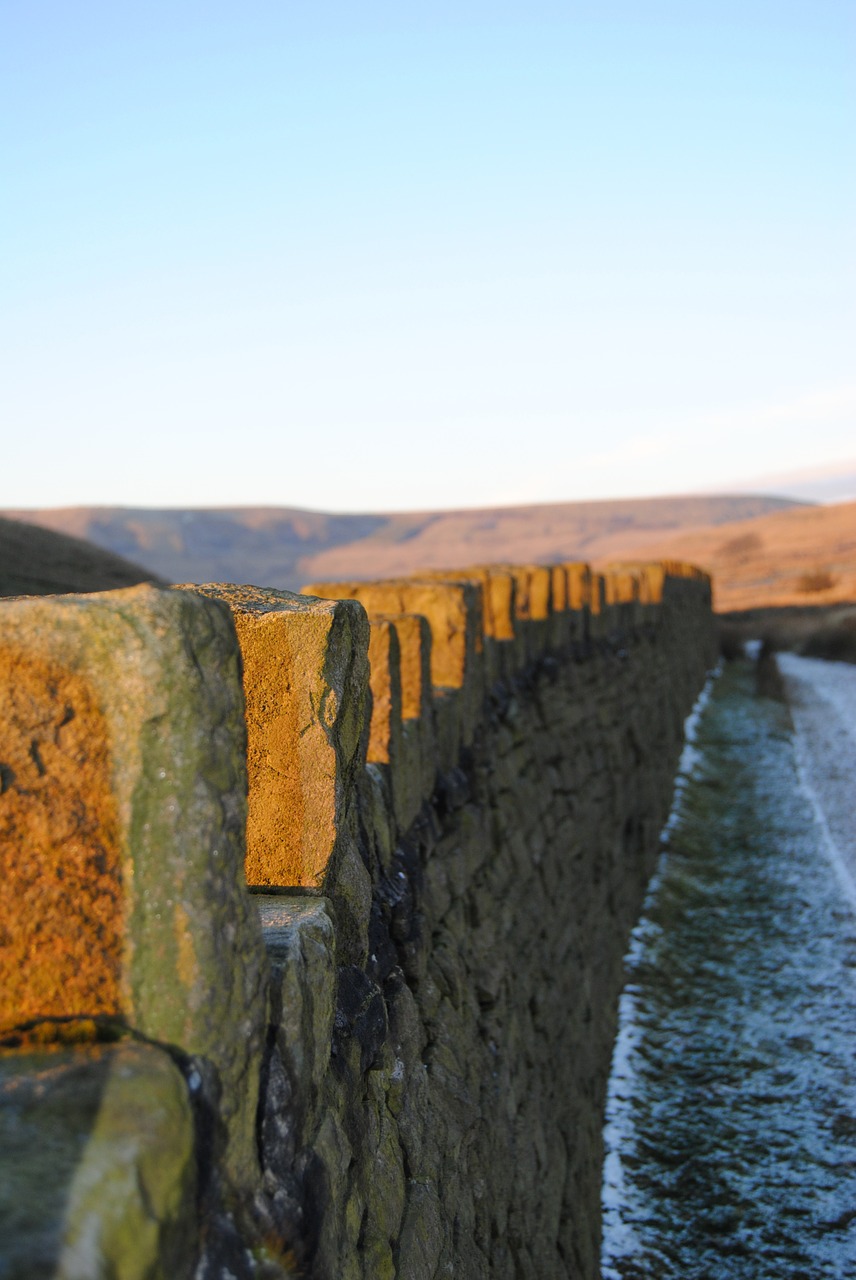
[4,495,801,590]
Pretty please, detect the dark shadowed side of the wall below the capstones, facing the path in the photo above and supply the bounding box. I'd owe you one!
[253,581,714,1280]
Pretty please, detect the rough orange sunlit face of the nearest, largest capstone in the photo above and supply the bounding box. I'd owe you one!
[0,649,125,1030]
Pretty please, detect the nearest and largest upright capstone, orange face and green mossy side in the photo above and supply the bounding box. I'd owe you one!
[0,586,266,1181]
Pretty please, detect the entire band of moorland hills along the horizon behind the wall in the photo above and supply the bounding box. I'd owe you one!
[0,495,856,632]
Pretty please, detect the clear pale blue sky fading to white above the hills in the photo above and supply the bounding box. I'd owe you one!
[0,0,856,509]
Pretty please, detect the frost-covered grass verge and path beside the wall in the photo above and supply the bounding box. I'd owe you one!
[603,655,856,1280]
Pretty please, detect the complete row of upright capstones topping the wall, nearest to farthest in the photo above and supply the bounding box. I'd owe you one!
[0,563,710,1183]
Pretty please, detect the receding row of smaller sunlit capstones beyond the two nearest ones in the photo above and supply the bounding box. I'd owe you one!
[300,562,710,849]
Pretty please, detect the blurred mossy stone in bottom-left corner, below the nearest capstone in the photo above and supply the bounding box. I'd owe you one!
[0,1043,198,1280]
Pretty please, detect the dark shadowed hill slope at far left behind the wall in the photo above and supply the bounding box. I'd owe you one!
[0,518,165,596]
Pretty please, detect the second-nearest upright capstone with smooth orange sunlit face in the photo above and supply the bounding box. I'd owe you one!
[184,584,369,890]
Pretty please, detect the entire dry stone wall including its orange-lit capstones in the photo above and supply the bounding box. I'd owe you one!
[0,563,713,1280]
